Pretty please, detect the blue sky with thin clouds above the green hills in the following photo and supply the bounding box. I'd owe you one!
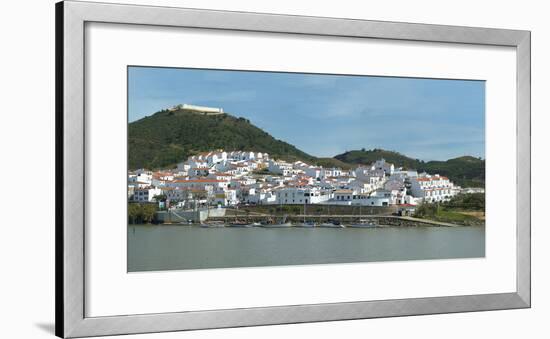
[128,67,485,160]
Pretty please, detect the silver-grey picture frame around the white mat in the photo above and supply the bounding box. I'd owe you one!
[55,1,531,337]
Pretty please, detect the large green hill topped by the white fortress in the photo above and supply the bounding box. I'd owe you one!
[128,109,316,169]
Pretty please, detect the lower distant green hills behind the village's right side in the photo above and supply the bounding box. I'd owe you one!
[334,149,485,187]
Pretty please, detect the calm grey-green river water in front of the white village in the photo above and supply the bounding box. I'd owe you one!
[128,225,485,272]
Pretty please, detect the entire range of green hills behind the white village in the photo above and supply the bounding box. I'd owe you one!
[128,109,485,187]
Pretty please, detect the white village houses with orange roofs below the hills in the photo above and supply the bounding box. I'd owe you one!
[128,149,468,209]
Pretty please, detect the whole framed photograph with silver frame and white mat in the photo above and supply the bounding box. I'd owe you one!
[56,1,531,337]
